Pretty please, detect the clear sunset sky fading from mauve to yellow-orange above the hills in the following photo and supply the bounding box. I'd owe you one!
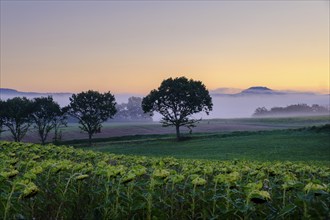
[0,0,330,94]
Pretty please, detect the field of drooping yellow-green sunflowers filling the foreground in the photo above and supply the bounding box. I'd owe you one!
[0,142,330,219]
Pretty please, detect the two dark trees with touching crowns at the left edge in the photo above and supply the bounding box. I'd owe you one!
[0,97,67,144]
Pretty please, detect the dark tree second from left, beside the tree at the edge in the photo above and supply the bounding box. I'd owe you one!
[32,96,62,144]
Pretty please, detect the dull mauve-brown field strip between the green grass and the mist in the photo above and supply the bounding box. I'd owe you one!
[0,116,330,143]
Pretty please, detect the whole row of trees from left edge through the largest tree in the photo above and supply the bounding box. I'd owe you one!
[0,77,212,145]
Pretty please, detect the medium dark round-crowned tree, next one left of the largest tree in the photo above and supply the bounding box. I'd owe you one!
[68,90,116,146]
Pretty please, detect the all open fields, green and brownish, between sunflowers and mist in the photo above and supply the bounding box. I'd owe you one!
[3,116,330,162]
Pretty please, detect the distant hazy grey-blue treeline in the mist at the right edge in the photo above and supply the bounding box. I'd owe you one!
[253,104,330,117]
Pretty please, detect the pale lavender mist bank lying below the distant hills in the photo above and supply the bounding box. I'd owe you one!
[0,90,330,121]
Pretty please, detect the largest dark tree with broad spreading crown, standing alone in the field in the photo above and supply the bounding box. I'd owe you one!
[142,77,213,140]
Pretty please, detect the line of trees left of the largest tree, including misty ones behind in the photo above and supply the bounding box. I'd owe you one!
[0,91,152,144]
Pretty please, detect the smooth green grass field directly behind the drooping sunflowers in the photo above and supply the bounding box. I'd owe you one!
[65,126,330,162]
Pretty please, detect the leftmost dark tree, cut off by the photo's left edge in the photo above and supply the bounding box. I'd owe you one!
[0,97,33,142]
